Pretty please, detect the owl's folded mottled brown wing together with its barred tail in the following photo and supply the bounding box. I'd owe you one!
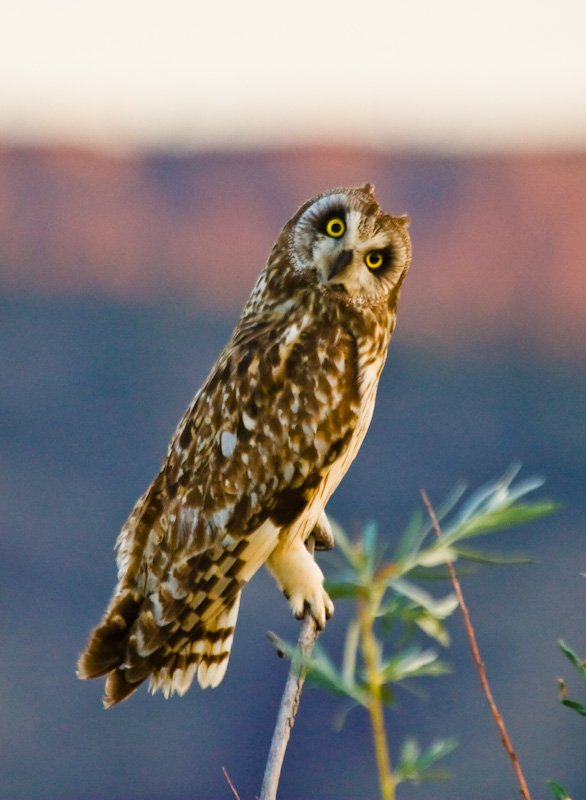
[80,321,358,704]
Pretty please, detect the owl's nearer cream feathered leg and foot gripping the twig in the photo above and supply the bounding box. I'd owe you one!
[267,541,334,630]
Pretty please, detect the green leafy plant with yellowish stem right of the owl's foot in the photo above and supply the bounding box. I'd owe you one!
[272,466,555,800]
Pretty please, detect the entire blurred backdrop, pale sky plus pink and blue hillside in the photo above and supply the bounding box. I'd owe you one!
[0,0,586,800]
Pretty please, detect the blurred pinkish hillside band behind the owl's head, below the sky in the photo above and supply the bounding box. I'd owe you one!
[0,148,586,357]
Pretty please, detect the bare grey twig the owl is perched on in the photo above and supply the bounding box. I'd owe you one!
[259,537,318,800]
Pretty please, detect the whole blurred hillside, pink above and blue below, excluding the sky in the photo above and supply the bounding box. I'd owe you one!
[0,148,586,800]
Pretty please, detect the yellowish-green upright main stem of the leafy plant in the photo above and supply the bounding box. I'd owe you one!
[360,602,395,800]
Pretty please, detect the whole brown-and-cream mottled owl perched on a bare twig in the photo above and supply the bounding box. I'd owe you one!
[78,184,411,707]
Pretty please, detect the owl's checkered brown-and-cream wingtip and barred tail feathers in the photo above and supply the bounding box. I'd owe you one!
[78,520,280,708]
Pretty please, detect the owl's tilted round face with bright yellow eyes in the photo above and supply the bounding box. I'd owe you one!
[289,184,411,305]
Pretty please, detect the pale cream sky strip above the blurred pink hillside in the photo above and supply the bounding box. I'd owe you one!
[0,0,586,152]
